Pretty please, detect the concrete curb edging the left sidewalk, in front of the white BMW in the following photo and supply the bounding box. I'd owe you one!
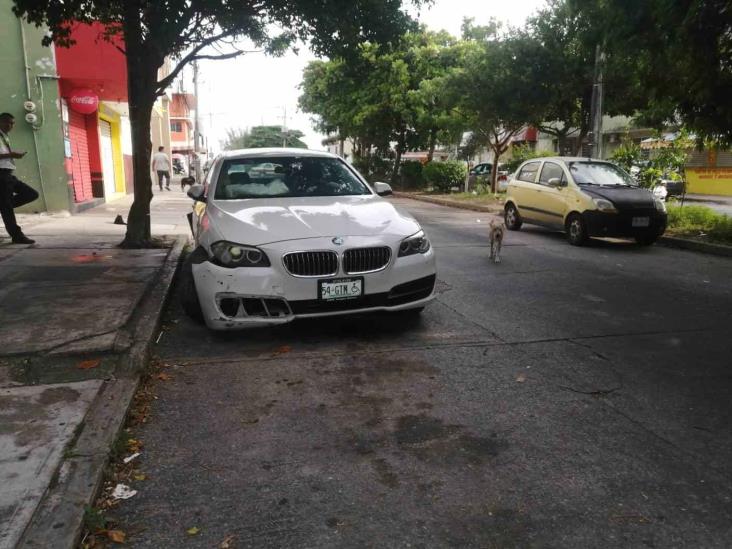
[16,237,187,549]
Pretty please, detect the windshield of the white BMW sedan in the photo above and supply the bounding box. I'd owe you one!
[214,156,371,200]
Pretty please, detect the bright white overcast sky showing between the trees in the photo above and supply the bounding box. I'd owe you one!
[192,0,545,151]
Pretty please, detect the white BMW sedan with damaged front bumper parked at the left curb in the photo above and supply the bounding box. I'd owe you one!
[181,149,436,330]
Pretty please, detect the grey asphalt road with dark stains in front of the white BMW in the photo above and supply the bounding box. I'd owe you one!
[113,201,732,548]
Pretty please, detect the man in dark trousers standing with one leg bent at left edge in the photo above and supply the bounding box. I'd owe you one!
[0,112,38,244]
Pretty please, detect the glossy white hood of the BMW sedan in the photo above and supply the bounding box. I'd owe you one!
[208,195,420,246]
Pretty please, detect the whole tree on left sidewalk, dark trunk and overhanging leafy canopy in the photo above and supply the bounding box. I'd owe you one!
[13,0,421,247]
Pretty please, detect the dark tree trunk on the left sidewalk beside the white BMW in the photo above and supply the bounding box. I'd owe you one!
[120,1,162,248]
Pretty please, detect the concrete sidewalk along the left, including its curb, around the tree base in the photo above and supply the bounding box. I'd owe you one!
[0,189,191,548]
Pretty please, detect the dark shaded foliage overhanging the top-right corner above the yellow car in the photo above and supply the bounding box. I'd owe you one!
[565,0,732,145]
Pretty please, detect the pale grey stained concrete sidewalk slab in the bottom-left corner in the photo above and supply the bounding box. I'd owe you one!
[0,380,103,547]
